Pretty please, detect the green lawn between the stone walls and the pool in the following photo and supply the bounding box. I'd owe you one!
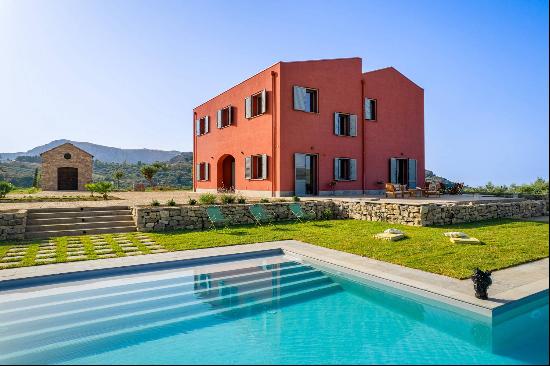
[0,219,549,278]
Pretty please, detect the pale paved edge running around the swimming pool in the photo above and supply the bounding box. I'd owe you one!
[0,240,549,316]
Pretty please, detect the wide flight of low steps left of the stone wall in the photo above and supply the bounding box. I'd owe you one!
[25,206,136,239]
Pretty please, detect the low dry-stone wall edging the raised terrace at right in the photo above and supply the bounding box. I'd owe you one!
[335,199,548,226]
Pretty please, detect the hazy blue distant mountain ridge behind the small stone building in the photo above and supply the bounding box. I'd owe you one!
[0,139,184,164]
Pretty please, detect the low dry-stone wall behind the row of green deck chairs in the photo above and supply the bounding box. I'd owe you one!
[132,201,335,231]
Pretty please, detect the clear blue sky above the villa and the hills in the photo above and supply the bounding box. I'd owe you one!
[0,0,549,185]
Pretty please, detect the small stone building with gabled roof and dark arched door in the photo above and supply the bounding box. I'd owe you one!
[40,143,93,191]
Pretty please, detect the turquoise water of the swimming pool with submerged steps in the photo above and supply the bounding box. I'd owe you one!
[0,262,548,364]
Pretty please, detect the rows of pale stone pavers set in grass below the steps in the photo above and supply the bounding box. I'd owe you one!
[0,234,167,270]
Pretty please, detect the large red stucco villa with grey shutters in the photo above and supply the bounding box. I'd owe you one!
[193,58,424,197]
